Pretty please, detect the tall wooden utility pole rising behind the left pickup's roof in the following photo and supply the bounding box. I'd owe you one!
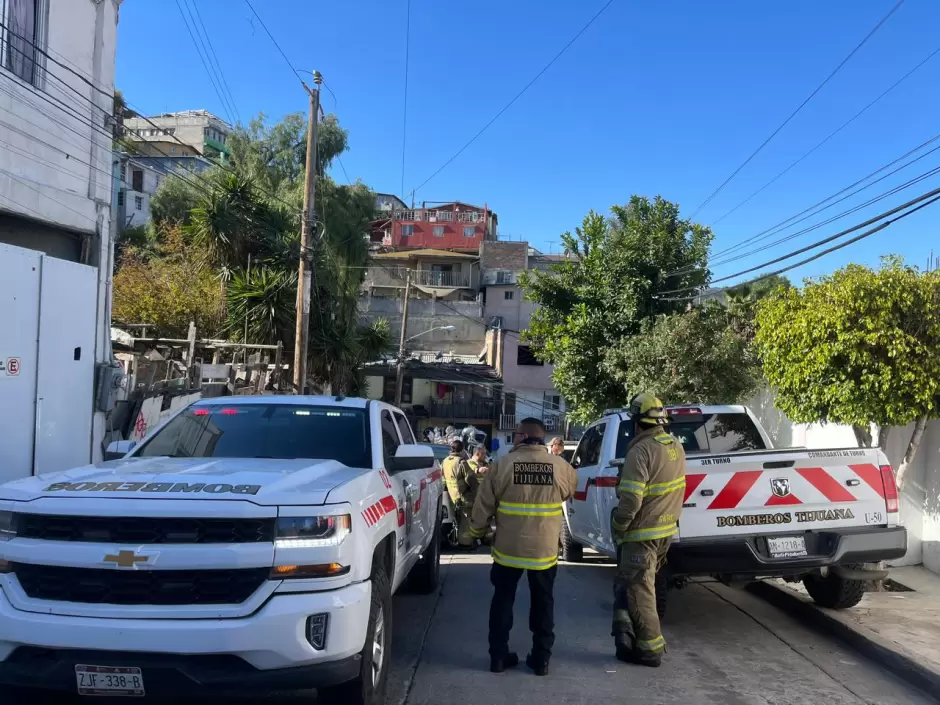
[294,71,323,394]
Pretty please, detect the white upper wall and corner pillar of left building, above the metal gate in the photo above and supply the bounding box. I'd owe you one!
[0,0,120,468]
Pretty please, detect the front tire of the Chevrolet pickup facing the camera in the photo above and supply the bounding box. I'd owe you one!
[317,565,392,705]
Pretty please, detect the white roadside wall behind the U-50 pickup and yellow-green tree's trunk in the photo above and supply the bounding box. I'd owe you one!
[747,384,940,573]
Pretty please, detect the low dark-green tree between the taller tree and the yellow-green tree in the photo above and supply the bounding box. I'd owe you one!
[604,303,762,404]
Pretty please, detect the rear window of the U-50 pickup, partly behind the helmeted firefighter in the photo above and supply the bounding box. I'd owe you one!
[617,414,767,458]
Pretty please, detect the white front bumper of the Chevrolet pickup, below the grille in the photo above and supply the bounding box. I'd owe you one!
[0,583,372,695]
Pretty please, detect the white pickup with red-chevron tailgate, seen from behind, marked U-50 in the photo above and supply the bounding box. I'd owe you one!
[561,406,907,611]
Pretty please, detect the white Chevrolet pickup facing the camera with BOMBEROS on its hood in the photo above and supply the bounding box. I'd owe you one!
[0,396,441,704]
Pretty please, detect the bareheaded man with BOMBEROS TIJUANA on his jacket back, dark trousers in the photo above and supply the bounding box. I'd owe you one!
[470,418,578,676]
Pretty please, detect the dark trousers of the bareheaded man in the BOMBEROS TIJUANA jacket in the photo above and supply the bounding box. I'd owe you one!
[490,563,558,663]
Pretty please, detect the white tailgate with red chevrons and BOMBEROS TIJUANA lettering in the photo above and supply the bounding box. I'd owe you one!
[679,448,896,541]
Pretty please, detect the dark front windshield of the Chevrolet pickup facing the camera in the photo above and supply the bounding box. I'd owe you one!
[134,403,372,468]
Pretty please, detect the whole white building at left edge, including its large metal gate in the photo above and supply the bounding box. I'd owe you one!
[0,0,121,481]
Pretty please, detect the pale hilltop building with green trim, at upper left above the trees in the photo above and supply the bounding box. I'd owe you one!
[124,110,232,162]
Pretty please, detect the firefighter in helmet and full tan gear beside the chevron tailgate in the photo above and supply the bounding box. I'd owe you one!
[612,393,685,667]
